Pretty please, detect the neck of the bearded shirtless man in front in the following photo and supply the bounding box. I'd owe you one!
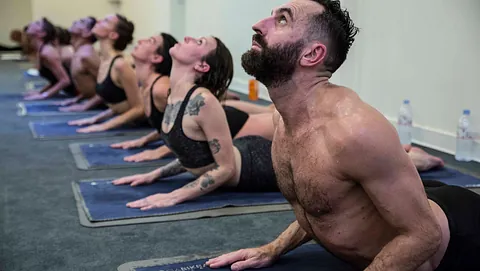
[268,72,330,131]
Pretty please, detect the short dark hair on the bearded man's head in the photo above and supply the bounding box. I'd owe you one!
[306,0,359,73]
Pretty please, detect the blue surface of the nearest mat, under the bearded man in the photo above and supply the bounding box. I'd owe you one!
[125,244,355,271]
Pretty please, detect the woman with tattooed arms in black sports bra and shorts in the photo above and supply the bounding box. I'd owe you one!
[113,37,278,210]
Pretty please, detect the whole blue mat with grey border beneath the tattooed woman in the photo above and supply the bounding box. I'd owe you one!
[72,173,291,228]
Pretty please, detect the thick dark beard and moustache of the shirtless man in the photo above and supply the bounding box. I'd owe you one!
[242,34,304,88]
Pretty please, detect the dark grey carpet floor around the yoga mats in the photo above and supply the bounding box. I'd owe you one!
[0,61,479,271]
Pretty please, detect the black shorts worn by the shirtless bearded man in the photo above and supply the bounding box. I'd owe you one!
[425,185,480,271]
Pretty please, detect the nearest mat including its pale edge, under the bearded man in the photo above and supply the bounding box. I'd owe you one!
[117,244,356,271]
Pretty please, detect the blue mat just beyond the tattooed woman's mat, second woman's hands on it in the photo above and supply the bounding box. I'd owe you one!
[70,141,175,170]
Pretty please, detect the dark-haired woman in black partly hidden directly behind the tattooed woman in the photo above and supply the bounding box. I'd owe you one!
[111,33,273,165]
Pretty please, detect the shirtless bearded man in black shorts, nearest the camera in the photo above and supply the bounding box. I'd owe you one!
[207,0,480,271]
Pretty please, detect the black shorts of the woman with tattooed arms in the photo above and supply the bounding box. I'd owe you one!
[233,136,280,192]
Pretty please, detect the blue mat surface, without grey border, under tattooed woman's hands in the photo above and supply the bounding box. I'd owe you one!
[76,173,287,222]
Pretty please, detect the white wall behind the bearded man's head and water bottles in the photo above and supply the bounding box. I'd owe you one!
[185,0,480,160]
